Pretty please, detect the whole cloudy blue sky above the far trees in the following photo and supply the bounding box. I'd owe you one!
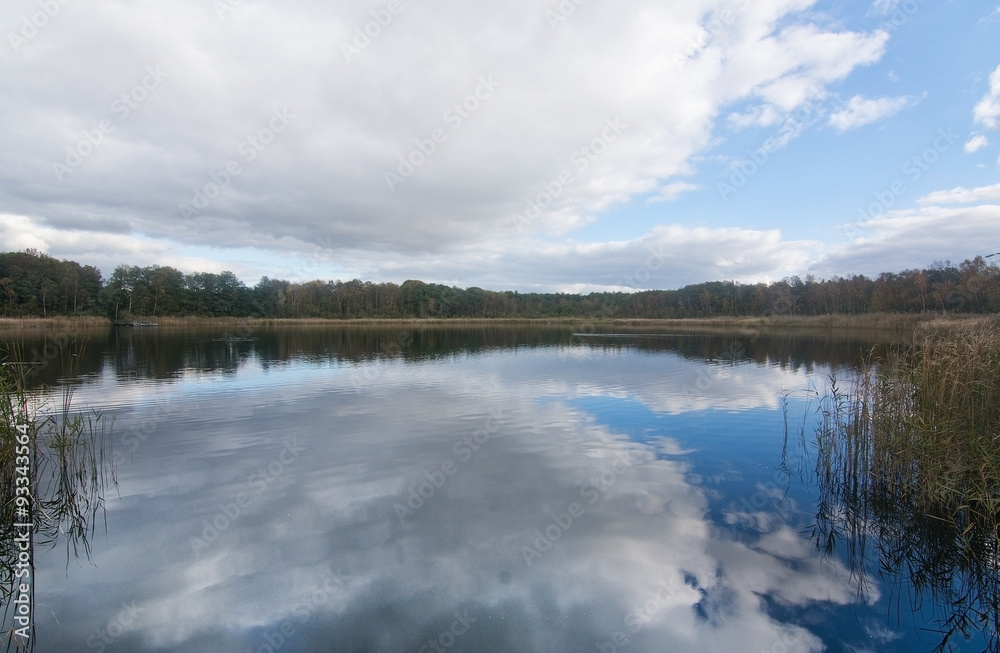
[0,0,1000,292]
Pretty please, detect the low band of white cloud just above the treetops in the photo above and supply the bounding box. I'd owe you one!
[7,182,1000,293]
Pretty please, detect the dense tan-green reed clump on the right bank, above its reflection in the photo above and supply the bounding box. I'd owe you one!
[851,319,1000,528]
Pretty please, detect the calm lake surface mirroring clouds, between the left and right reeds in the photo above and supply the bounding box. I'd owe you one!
[1,327,983,653]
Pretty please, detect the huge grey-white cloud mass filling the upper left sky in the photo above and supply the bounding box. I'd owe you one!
[0,0,888,287]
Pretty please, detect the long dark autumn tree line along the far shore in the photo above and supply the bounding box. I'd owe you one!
[0,249,1000,320]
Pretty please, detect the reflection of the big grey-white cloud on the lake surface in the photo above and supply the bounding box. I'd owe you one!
[46,348,857,653]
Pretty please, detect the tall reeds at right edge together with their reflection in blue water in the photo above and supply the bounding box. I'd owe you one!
[814,318,1000,651]
